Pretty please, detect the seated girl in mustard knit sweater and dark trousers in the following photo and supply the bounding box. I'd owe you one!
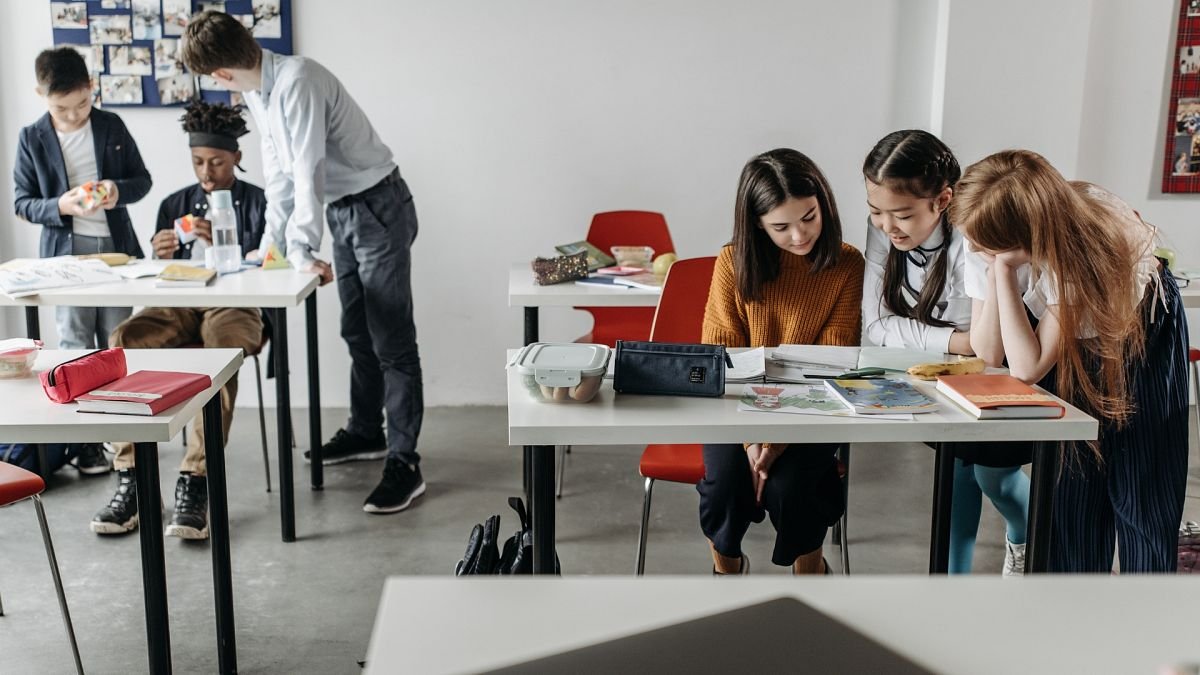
[697,149,864,574]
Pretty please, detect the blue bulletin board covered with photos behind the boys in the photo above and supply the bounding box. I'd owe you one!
[50,0,292,108]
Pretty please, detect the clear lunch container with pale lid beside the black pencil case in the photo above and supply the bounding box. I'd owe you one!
[514,342,612,404]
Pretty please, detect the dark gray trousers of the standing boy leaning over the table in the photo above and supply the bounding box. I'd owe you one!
[325,171,425,465]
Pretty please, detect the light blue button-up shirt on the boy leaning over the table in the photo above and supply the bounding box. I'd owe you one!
[245,49,396,268]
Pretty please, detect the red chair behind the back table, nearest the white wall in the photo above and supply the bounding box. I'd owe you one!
[575,211,674,347]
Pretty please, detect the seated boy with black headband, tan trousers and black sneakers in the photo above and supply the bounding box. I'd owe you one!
[91,101,266,539]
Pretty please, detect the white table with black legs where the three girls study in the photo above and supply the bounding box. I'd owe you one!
[508,350,1098,573]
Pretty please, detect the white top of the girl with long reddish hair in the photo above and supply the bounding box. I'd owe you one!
[964,185,1158,338]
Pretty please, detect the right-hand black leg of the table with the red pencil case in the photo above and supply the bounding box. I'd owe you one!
[204,393,238,674]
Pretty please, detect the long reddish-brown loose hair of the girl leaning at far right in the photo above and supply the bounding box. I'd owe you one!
[950,150,1145,437]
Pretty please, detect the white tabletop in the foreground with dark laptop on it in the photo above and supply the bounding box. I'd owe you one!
[364,575,1200,675]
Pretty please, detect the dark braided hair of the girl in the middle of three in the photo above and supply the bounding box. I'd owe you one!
[863,129,962,328]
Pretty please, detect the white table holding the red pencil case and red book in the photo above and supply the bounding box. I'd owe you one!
[0,350,242,673]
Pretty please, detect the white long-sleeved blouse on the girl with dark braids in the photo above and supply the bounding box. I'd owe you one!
[863,223,986,353]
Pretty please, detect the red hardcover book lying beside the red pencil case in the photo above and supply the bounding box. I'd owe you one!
[76,370,212,414]
